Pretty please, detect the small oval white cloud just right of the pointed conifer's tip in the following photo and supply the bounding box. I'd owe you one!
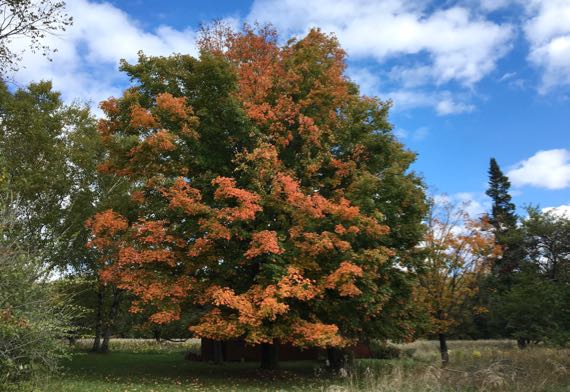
[507,149,570,189]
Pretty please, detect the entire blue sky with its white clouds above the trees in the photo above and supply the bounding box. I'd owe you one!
[10,0,570,213]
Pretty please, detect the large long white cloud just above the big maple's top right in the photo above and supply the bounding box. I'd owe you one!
[249,0,513,85]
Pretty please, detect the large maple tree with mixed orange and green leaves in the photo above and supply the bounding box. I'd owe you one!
[88,26,425,368]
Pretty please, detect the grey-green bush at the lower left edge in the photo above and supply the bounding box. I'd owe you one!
[0,194,75,389]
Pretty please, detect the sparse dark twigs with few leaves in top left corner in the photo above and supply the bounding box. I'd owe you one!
[0,0,73,77]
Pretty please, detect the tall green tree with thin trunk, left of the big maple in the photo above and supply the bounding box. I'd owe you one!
[0,82,129,351]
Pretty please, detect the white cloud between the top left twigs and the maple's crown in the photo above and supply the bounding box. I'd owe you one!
[9,0,202,108]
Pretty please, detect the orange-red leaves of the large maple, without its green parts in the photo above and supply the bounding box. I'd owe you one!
[88,28,400,347]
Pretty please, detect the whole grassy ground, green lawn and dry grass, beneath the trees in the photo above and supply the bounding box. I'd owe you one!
[36,340,570,392]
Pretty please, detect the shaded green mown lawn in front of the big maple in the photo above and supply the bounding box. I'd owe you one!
[45,352,325,392]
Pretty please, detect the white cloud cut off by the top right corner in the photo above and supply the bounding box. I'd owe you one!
[524,0,570,94]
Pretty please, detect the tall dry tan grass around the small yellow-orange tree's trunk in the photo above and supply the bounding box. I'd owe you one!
[329,341,570,392]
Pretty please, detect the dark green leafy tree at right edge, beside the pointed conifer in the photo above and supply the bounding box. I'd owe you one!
[492,207,570,348]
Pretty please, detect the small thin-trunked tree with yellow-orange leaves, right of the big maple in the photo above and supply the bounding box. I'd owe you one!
[419,200,500,364]
